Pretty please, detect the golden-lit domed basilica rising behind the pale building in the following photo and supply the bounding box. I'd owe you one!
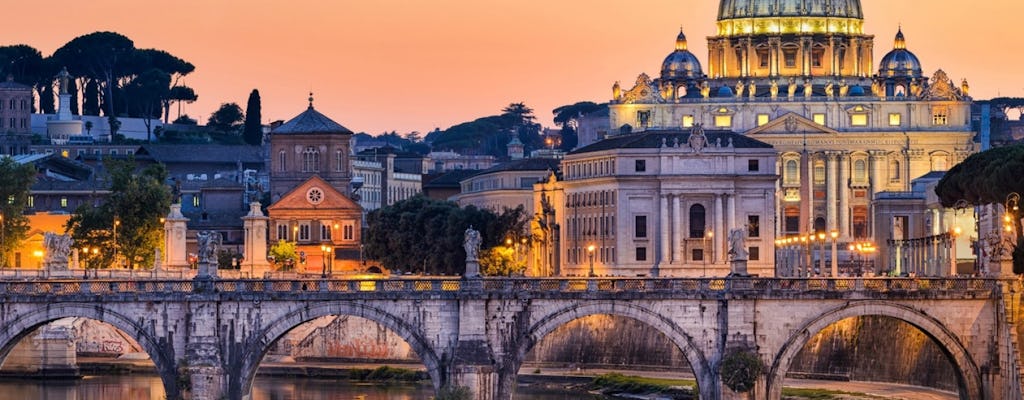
[608,0,975,263]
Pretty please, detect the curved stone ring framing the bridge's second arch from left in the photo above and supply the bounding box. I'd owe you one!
[235,301,444,399]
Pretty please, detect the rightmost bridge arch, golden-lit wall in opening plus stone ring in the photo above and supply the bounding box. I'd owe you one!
[768,302,982,399]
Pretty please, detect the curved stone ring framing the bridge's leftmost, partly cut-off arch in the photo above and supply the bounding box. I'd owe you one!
[0,303,181,399]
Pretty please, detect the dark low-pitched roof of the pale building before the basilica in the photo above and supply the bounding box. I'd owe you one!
[569,129,772,154]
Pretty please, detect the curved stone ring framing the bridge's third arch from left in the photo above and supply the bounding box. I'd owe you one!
[512,301,718,399]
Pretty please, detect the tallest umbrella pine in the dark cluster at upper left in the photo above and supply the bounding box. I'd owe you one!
[52,32,135,116]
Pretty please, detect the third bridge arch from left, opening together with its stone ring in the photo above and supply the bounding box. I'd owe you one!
[512,302,717,399]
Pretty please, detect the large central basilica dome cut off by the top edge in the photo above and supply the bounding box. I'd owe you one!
[718,0,864,36]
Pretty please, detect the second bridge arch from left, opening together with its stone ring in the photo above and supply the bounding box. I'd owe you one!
[237,302,443,399]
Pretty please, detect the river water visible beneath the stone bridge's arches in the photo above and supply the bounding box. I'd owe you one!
[0,375,607,400]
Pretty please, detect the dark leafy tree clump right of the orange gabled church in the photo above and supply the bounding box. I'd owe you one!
[364,195,526,274]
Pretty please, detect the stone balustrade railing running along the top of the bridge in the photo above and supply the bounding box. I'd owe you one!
[0,276,1002,296]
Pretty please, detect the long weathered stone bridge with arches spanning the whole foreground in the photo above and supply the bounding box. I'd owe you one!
[0,278,1024,400]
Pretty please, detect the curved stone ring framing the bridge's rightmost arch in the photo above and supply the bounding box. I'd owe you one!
[767,301,984,400]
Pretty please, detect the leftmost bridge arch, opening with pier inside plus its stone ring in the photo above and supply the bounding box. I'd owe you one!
[0,304,181,399]
